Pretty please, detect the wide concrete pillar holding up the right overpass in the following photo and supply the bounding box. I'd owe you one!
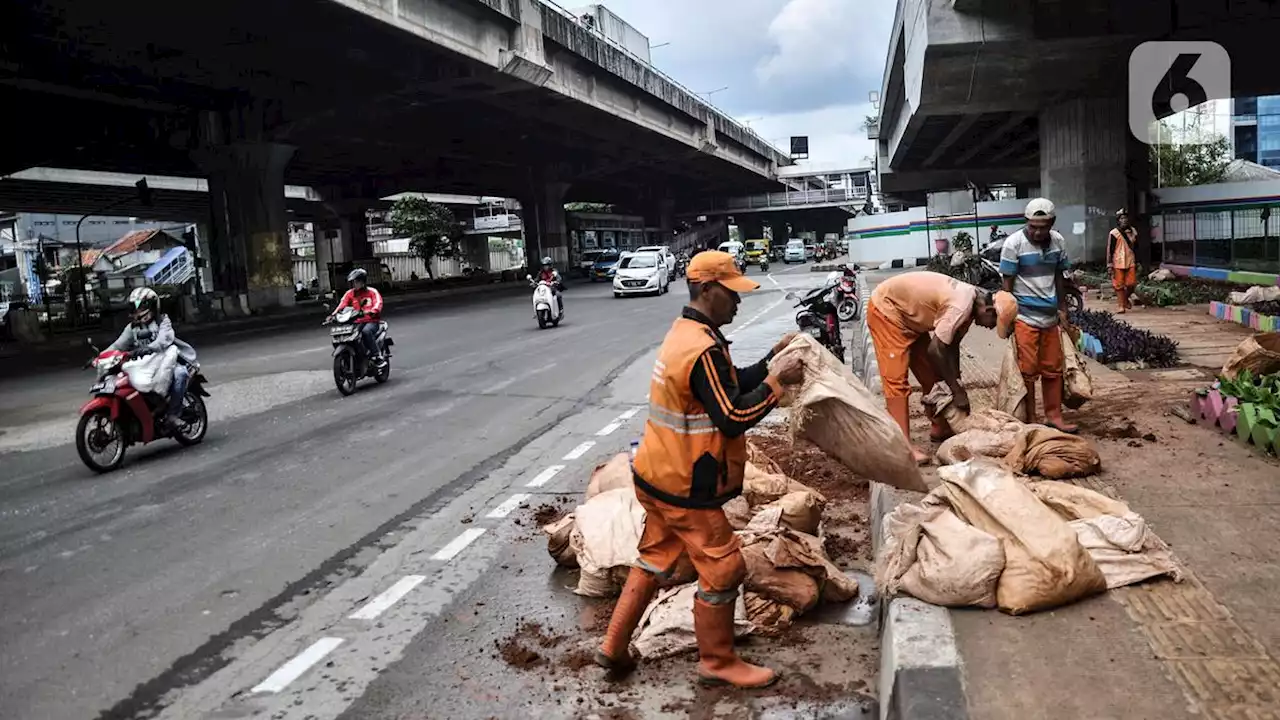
[1039,99,1147,261]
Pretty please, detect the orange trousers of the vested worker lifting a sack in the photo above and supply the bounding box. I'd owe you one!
[636,488,746,603]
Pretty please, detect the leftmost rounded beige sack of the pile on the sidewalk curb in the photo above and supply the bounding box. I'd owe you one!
[876,488,1005,607]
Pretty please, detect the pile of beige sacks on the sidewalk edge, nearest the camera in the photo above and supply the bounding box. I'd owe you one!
[876,459,1181,615]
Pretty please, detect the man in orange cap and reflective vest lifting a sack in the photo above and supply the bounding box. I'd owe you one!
[595,250,804,688]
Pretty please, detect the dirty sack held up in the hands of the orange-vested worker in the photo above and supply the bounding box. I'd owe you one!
[773,334,928,492]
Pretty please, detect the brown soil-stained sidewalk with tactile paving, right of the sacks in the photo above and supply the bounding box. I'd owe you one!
[914,303,1280,720]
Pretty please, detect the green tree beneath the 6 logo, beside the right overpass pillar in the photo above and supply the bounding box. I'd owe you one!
[1149,111,1231,187]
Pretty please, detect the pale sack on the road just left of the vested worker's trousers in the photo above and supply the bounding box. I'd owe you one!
[571,488,644,597]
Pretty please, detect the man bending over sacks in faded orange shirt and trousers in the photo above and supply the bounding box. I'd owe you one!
[867,272,1016,464]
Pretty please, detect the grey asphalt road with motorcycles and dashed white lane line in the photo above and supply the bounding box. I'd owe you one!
[0,268,829,719]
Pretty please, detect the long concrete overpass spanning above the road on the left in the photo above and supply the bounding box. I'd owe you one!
[0,0,790,306]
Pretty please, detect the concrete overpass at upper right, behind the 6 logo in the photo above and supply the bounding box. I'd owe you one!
[874,0,1280,256]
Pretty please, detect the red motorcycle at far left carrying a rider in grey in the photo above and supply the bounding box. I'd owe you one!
[76,341,209,473]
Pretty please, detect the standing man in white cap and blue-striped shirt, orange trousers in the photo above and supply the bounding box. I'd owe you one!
[1000,197,1076,433]
